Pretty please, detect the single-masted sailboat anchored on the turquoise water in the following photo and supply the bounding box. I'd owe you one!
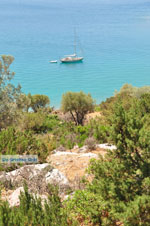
[60,32,83,63]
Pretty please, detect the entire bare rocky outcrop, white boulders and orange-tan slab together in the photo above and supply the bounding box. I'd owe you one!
[0,144,116,206]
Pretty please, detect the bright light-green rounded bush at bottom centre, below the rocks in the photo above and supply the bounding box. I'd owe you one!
[66,190,103,226]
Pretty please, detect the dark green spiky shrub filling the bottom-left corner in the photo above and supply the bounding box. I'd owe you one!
[0,186,67,226]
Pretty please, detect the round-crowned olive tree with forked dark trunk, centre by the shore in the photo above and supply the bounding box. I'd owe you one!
[61,91,95,125]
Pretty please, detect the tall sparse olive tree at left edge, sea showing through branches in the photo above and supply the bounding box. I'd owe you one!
[0,55,21,130]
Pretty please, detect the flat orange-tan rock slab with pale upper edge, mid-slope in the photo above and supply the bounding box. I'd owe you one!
[47,144,116,188]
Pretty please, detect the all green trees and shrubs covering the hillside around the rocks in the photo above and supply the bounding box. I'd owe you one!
[0,56,150,226]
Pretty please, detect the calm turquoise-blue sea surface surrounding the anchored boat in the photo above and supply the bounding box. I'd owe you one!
[0,0,150,108]
